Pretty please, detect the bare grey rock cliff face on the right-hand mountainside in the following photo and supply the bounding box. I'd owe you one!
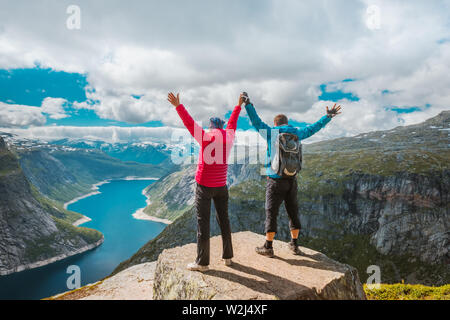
[342,170,450,264]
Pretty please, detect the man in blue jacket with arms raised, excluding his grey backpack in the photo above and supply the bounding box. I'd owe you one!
[245,102,341,257]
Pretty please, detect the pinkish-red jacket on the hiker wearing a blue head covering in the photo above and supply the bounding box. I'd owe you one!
[177,104,241,188]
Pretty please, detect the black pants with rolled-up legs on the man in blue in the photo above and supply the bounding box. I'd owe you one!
[265,178,301,233]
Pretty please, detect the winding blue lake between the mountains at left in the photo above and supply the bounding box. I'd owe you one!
[0,180,166,299]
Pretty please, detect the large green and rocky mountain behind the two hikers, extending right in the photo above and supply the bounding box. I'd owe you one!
[114,111,450,285]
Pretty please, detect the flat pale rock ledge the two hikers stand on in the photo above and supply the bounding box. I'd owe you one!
[153,232,365,300]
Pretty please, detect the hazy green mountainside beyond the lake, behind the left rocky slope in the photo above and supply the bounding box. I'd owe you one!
[0,133,174,202]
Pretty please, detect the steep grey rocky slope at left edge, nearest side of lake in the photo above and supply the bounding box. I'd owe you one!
[0,137,103,275]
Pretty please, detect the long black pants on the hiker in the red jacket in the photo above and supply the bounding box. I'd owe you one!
[195,183,233,266]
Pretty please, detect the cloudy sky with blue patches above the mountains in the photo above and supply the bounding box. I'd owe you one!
[0,0,450,141]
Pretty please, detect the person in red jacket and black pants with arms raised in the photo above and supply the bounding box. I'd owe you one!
[168,93,245,271]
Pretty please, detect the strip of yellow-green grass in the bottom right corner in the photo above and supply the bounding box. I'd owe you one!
[364,283,450,300]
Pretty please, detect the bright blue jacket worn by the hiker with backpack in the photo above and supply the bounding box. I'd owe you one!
[245,103,331,179]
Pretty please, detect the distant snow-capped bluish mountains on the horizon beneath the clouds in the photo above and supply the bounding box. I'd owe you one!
[51,138,172,164]
